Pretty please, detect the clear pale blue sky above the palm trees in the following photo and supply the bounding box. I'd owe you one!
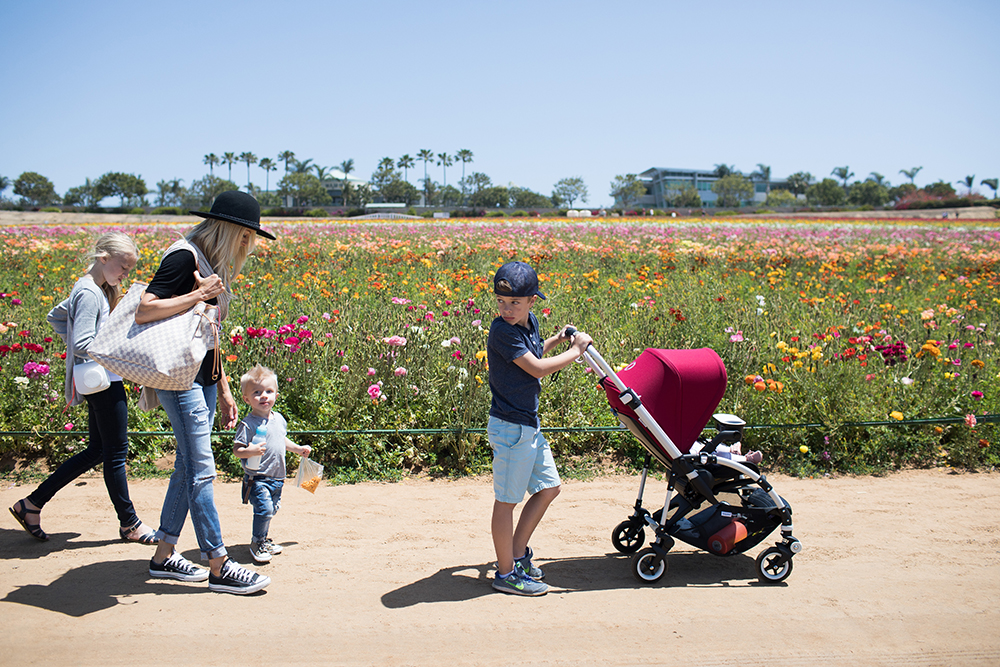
[0,0,1000,206]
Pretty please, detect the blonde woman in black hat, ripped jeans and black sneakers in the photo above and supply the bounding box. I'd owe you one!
[135,191,274,595]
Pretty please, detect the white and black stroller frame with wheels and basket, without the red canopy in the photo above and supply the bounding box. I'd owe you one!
[571,340,802,583]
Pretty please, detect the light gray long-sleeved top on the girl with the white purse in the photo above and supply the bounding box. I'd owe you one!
[45,274,121,405]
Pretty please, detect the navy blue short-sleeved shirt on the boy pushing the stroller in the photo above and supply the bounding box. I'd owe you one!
[486,312,544,428]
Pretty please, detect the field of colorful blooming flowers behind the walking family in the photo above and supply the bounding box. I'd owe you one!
[0,218,1000,479]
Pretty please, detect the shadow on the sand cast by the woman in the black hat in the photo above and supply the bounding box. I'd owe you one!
[0,540,225,618]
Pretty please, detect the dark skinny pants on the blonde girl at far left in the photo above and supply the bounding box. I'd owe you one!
[28,382,139,526]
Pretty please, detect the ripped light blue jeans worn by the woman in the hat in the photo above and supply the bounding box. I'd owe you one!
[156,383,226,559]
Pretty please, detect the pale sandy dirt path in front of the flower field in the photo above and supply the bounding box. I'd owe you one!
[0,470,1000,666]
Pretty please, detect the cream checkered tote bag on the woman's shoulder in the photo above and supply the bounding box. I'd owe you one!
[87,282,219,391]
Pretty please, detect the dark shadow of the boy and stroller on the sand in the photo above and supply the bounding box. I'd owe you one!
[382,552,757,609]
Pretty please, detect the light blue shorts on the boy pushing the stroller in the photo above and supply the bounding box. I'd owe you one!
[486,417,560,505]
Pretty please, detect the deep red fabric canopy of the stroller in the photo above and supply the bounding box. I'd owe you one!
[603,348,726,454]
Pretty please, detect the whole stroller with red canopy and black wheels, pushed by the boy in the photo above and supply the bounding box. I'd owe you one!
[584,334,802,583]
